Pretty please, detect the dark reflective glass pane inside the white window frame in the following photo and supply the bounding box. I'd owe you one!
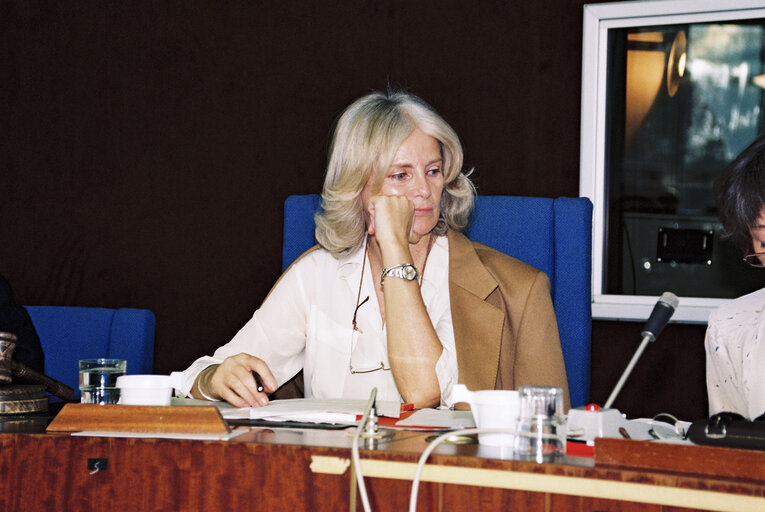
[603,20,765,298]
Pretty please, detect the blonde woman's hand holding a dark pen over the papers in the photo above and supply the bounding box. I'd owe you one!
[195,353,277,407]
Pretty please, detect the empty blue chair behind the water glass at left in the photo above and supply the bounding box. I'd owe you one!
[26,306,156,397]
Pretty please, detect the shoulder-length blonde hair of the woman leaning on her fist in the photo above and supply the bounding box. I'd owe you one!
[315,91,475,256]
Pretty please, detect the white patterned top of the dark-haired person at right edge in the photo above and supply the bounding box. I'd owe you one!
[705,288,765,419]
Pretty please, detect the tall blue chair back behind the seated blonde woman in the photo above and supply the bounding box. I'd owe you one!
[282,194,592,407]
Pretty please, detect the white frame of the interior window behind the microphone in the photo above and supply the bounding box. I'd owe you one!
[579,0,765,323]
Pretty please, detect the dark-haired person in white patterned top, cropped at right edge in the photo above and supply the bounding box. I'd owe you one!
[705,136,765,418]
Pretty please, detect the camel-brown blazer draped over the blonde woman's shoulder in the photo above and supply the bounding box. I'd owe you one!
[448,230,571,411]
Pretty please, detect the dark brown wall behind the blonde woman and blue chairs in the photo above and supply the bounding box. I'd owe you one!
[0,0,705,415]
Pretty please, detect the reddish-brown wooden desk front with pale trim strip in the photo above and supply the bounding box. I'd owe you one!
[0,428,765,512]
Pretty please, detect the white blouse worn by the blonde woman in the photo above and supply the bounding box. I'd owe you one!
[181,236,457,406]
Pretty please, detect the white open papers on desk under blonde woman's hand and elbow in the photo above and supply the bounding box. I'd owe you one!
[221,398,401,424]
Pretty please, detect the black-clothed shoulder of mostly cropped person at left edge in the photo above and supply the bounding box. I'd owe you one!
[0,274,45,373]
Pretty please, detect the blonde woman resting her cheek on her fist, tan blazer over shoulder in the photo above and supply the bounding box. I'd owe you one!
[183,92,568,407]
